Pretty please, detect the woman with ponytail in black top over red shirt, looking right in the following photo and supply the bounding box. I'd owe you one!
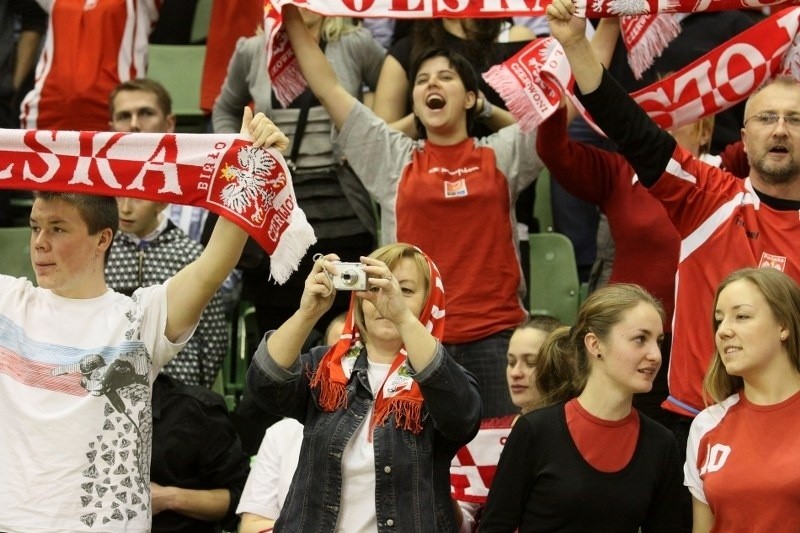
[481,284,681,533]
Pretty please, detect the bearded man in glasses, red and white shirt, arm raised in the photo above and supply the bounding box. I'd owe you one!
[548,0,800,528]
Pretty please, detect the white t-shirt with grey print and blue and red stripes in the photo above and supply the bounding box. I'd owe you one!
[0,275,187,533]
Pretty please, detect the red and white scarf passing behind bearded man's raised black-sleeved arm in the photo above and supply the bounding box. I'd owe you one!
[484,7,800,131]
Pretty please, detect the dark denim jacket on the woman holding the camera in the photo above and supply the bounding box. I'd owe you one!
[247,337,481,533]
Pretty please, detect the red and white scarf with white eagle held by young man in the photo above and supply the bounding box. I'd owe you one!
[0,129,316,283]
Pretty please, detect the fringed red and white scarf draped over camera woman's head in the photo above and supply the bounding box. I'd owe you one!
[310,249,445,435]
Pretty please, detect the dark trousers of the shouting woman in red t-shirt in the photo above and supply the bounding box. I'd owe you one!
[444,329,519,418]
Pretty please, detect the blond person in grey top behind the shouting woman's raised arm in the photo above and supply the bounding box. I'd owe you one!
[212,9,385,336]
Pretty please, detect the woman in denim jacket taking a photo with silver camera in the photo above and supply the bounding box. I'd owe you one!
[247,244,481,532]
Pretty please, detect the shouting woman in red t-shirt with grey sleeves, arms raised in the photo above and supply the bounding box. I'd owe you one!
[282,5,542,417]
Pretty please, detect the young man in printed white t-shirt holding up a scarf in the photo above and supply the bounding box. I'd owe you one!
[0,110,288,532]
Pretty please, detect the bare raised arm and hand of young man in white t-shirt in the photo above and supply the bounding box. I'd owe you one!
[164,107,289,342]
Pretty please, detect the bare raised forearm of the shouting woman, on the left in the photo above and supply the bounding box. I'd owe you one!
[282,5,356,128]
